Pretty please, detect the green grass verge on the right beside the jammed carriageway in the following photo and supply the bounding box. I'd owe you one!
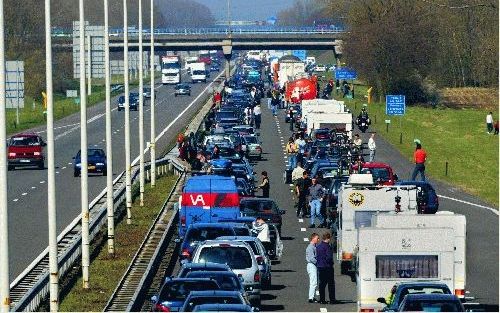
[343,85,499,207]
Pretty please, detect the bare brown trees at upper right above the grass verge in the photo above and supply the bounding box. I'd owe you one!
[280,0,499,103]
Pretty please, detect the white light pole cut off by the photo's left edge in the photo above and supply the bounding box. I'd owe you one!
[0,0,10,312]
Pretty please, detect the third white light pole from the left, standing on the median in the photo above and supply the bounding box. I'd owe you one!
[79,0,90,289]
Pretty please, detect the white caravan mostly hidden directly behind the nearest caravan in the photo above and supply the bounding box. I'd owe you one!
[372,211,467,299]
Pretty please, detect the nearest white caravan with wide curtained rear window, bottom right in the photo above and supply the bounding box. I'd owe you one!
[356,227,455,312]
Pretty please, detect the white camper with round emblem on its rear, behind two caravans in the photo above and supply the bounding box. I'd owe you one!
[334,174,417,275]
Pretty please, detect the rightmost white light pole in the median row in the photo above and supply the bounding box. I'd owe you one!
[149,0,156,188]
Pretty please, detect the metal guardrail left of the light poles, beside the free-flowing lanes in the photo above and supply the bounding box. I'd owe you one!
[10,157,184,312]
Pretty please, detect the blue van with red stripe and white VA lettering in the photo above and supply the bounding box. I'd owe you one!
[179,175,240,237]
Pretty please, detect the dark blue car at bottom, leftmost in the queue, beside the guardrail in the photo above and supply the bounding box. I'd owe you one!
[151,277,220,312]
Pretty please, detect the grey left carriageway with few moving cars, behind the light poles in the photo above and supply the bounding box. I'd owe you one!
[8,69,224,281]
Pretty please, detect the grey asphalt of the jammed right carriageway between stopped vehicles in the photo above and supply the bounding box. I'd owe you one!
[154,101,499,312]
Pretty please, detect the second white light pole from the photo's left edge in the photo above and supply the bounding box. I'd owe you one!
[45,0,59,312]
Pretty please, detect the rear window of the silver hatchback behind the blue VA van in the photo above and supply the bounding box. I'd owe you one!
[198,244,252,270]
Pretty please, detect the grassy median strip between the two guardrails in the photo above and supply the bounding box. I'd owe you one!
[59,176,177,312]
